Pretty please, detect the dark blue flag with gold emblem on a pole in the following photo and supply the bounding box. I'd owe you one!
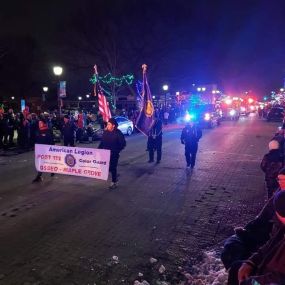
[136,64,155,136]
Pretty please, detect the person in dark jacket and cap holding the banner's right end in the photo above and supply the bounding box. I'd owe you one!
[99,118,126,189]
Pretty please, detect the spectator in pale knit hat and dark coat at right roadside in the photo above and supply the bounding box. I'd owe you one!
[260,140,283,199]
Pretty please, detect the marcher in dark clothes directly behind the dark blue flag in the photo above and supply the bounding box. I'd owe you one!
[147,113,162,163]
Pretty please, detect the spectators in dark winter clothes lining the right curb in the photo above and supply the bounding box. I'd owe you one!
[221,120,285,285]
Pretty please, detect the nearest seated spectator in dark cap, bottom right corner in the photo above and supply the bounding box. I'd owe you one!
[231,191,285,285]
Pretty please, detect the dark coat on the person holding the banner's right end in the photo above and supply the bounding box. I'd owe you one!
[98,128,126,153]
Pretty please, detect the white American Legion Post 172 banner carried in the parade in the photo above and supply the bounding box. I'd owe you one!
[35,144,110,180]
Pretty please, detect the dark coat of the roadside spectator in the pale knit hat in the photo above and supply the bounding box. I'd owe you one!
[260,149,283,180]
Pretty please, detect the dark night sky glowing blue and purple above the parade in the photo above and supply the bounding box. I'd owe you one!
[0,0,285,98]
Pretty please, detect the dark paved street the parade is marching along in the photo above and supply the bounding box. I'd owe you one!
[0,116,278,285]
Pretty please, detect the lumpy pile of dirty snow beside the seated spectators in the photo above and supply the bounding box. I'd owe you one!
[189,251,228,285]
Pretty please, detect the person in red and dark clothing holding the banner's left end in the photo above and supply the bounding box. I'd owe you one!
[33,114,54,182]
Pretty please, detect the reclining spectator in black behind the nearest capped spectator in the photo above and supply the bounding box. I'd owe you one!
[221,167,285,270]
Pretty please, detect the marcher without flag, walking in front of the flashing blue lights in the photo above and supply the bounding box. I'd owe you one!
[180,121,202,168]
